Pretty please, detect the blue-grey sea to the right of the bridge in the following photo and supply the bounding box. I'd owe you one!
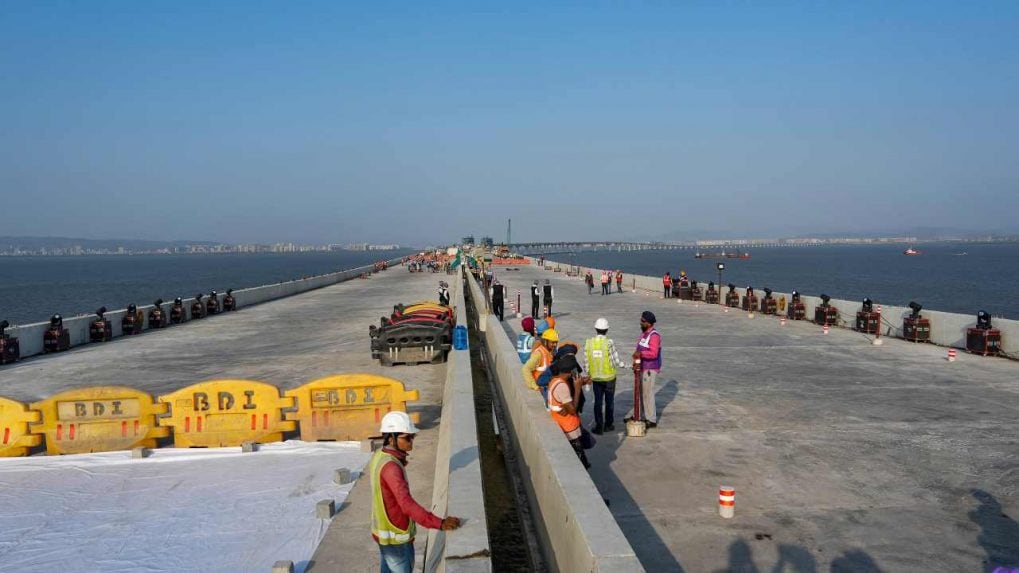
[549,243,1019,319]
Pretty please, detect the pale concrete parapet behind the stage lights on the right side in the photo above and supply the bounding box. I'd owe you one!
[558,260,1019,356]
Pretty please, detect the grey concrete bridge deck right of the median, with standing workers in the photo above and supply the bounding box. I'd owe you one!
[495,266,1019,572]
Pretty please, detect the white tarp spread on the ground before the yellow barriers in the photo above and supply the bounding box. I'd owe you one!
[0,441,370,573]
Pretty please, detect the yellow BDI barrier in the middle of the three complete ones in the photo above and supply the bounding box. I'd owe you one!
[159,380,298,448]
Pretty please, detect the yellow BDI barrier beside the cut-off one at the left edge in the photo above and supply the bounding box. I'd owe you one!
[32,386,170,455]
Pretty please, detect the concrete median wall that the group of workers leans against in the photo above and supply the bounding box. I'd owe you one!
[468,276,644,572]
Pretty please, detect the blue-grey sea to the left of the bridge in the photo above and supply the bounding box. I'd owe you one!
[0,251,411,324]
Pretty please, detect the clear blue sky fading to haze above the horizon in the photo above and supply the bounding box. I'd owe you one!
[0,0,1019,245]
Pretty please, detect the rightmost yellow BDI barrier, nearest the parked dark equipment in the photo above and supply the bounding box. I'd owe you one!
[286,374,420,441]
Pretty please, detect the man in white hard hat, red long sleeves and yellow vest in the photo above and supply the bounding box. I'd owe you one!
[368,412,460,573]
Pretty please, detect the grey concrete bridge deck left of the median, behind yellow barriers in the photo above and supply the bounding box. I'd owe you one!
[0,267,446,571]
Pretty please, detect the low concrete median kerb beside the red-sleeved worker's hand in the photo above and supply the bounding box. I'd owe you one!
[425,267,492,573]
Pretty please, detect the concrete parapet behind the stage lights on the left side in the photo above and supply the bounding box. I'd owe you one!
[0,254,401,358]
